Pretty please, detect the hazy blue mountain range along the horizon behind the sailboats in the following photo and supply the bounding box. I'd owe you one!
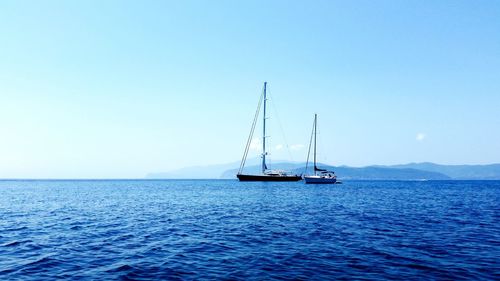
[146,158,500,180]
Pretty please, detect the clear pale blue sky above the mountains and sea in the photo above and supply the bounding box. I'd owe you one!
[0,0,500,178]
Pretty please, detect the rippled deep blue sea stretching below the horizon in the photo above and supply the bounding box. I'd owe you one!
[0,180,500,280]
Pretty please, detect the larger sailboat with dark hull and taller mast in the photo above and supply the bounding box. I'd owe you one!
[236,82,302,181]
